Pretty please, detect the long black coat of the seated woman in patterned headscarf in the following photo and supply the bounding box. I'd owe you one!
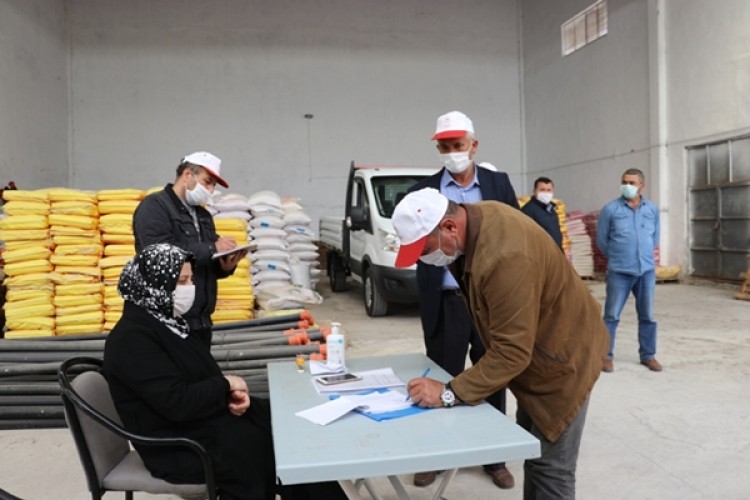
[103,302,276,499]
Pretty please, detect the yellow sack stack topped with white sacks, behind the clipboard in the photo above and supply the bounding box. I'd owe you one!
[209,194,255,324]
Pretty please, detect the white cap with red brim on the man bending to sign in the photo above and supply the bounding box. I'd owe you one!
[391,188,448,267]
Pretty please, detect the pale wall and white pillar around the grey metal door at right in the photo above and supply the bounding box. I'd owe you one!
[662,0,750,269]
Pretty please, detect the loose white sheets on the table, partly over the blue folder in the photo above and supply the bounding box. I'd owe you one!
[295,391,413,425]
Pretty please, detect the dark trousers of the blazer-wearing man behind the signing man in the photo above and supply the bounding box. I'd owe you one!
[424,291,506,470]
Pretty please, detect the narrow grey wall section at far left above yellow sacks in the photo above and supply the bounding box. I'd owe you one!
[0,0,69,189]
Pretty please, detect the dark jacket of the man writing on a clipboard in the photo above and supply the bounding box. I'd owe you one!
[133,184,231,330]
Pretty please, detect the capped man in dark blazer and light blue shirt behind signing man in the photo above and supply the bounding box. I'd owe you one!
[409,111,518,489]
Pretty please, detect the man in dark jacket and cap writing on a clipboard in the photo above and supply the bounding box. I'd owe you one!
[133,151,247,347]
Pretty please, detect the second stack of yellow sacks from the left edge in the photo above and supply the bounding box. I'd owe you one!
[47,188,104,335]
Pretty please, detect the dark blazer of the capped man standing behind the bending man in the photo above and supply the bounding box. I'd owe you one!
[409,164,518,338]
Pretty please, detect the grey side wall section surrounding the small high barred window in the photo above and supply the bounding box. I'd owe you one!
[522,0,654,212]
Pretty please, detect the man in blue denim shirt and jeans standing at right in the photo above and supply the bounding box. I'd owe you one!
[596,168,662,372]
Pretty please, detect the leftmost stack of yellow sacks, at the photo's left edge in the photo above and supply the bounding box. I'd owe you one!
[0,190,55,339]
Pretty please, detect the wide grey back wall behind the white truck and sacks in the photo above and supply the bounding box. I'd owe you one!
[69,0,522,225]
